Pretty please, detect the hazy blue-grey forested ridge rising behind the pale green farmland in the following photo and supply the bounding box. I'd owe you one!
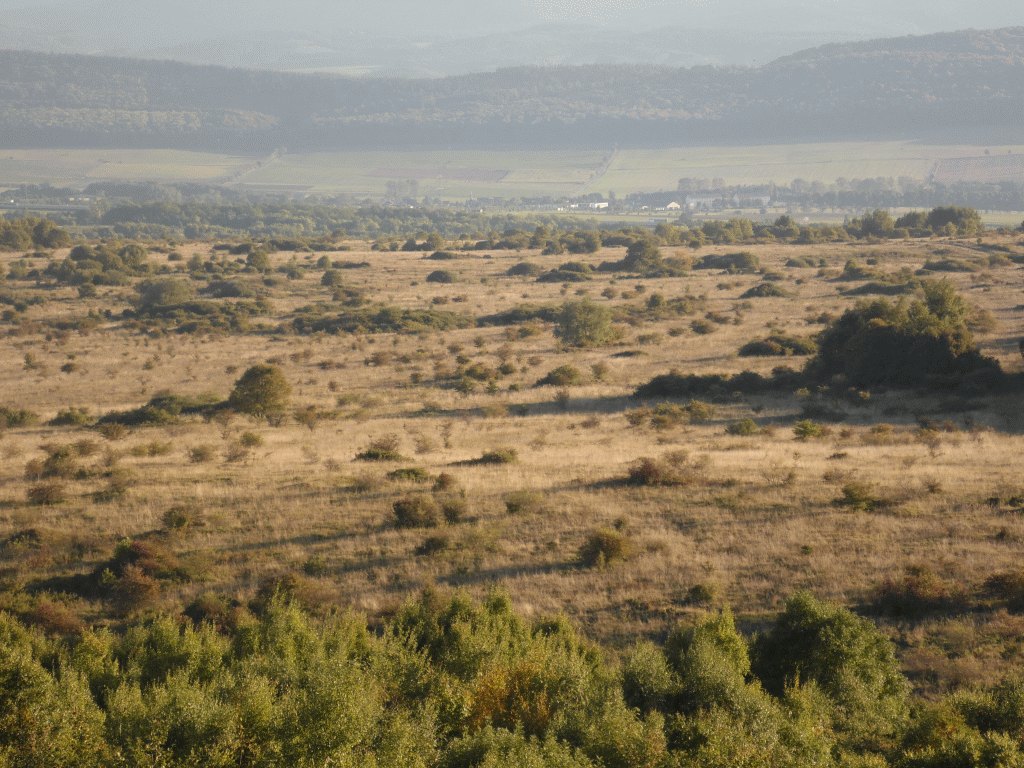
[0,28,1024,153]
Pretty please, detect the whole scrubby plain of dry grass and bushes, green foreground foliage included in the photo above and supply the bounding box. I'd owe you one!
[0,214,1024,768]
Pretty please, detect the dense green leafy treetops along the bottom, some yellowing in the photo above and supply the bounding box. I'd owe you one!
[0,593,1024,768]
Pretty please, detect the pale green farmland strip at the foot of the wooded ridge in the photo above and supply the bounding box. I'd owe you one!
[6,141,1024,200]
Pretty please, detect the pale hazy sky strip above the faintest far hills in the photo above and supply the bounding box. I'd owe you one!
[0,0,1024,37]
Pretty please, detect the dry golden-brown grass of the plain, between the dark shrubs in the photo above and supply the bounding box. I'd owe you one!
[0,230,1024,690]
